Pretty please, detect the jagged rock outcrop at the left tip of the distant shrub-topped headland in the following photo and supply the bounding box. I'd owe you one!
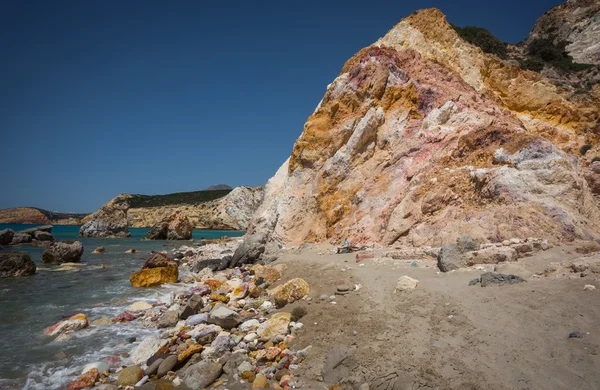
[79,195,131,238]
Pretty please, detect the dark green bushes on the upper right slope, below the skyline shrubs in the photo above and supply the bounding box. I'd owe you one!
[521,37,594,72]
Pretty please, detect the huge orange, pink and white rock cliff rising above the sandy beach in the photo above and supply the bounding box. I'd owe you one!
[240,9,600,258]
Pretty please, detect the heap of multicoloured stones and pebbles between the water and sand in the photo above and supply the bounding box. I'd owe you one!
[46,240,318,390]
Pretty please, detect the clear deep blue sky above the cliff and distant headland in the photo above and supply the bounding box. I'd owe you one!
[0,0,561,212]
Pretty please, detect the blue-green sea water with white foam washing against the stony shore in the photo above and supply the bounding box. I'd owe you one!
[0,224,243,389]
